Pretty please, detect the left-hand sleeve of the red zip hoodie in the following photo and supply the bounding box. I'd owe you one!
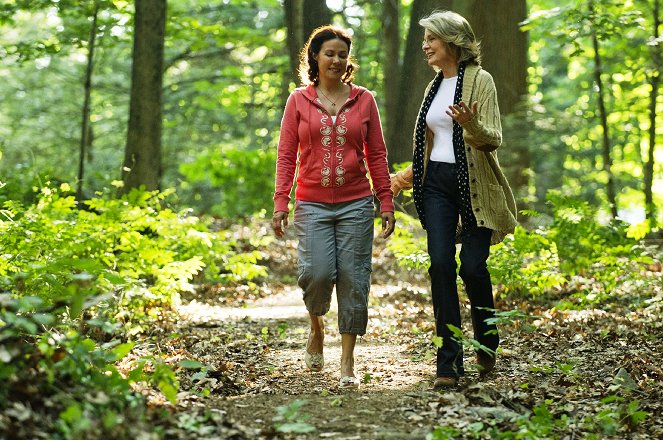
[274,92,299,212]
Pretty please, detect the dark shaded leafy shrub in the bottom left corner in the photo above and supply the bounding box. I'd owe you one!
[0,293,158,439]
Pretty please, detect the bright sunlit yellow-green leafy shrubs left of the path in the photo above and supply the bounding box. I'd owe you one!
[0,185,264,310]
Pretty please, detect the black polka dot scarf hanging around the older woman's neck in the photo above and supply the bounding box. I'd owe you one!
[412,63,476,232]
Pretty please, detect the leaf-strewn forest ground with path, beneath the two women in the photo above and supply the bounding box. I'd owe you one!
[136,237,663,439]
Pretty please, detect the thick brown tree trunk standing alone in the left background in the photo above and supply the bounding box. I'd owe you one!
[122,0,166,193]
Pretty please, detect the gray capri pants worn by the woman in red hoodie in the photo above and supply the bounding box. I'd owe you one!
[295,196,375,335]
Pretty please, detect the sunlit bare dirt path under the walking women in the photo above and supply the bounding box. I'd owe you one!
[181,286,438,439]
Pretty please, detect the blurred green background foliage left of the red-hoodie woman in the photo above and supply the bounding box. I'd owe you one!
[0,0,288,211]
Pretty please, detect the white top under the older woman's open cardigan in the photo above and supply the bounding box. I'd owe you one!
[426,76,458,163]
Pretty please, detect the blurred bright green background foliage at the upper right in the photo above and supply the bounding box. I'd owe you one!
[528,0,663,222]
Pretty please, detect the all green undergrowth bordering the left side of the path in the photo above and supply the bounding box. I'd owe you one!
[0,184,265,438]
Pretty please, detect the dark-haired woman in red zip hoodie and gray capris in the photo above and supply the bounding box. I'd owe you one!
[272,26,394,388]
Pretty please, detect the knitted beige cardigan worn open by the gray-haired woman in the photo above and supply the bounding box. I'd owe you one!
[391,65,517,244]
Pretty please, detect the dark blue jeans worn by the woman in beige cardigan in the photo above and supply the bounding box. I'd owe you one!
[423,161,499,377]
